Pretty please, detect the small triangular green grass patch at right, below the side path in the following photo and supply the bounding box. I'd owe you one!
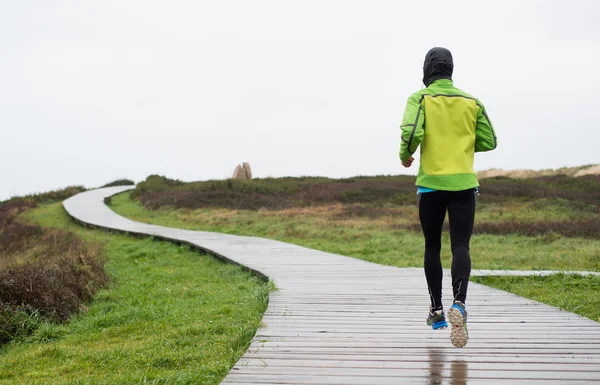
[472,274,600,322]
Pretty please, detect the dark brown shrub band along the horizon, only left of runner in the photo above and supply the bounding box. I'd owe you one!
[132,176,416,210]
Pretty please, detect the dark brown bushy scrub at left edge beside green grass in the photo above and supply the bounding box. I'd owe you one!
[0,189,108,344]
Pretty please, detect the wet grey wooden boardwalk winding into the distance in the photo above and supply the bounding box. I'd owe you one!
[64,187,600,385]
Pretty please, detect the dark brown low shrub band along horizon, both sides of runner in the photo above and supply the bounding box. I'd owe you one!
[132,175,600,211]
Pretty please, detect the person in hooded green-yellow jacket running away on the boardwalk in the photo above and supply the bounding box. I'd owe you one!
[400,47,497,347]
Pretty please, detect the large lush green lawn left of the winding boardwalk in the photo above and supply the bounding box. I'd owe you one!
[0,204,270,384]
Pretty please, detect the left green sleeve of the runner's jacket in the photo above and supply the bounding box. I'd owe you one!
[400,93,425,162]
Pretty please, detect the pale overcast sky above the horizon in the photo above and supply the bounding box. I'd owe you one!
[0,0,600,199]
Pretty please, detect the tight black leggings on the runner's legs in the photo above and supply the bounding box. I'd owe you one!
[419,189,477,310]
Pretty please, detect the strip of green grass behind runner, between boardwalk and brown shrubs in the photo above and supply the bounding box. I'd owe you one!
[112,193,600,271]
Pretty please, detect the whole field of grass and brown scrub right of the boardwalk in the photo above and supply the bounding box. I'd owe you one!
[112,176,600,320]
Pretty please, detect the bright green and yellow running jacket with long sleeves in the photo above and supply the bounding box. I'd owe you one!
[400,79,497,191]
